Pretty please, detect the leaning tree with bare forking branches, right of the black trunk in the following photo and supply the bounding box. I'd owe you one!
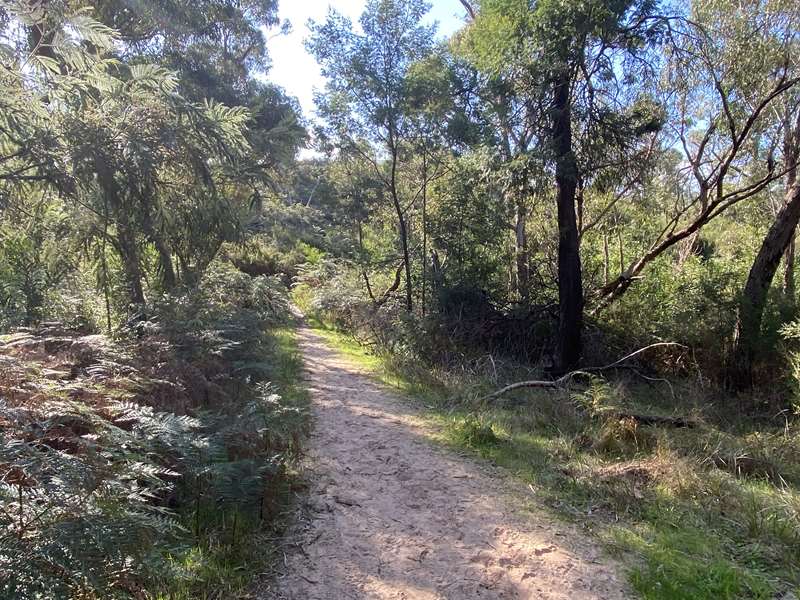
[595,0,798,310]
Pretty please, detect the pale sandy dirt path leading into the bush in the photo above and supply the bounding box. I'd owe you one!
[261,329,628,600]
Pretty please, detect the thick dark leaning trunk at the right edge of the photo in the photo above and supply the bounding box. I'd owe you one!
[728,169,800,390]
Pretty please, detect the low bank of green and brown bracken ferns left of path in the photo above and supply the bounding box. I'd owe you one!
[0,265,306,600]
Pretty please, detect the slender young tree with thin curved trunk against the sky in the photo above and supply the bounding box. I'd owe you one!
[307,0,435,312]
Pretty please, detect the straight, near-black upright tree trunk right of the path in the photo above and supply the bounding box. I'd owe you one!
[553,73,583,372]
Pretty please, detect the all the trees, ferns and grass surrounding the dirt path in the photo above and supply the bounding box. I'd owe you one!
[0,0,800,600]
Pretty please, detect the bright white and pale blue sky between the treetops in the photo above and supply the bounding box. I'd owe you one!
[267,0,464,122]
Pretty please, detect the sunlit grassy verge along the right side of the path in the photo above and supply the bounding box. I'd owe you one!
[310,323,800,600]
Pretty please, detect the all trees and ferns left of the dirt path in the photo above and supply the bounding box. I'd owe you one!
[0,0,307,600]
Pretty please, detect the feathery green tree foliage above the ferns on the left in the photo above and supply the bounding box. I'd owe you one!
[0,1,304,327]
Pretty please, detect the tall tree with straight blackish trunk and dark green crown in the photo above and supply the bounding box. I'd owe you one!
[460,0,664,371]
